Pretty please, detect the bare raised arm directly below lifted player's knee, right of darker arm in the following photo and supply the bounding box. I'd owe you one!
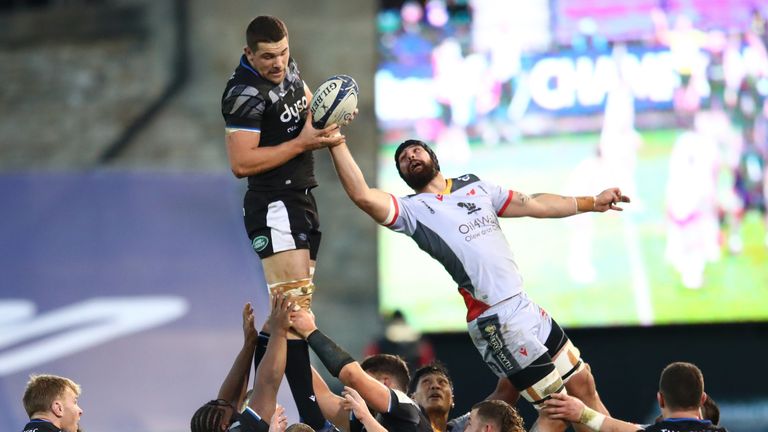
[249,294,292,419]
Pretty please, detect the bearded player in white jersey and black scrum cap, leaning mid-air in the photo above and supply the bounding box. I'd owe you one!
[330,140,629,431]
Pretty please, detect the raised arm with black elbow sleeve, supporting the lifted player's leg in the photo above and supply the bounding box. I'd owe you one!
[291,309,390,413]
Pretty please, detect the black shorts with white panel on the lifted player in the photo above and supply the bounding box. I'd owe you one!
[243,189,320,260]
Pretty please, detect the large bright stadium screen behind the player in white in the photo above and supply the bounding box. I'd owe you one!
[375,0,768,331]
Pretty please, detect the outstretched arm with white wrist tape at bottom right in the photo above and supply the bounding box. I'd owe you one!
[541,393,643,432]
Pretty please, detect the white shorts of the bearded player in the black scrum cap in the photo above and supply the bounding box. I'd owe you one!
[467,292,552,378]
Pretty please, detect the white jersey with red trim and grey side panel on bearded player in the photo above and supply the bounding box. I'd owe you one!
[382,174,523,321]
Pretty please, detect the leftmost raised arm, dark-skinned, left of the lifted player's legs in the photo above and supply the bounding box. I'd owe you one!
[217,303,258,406]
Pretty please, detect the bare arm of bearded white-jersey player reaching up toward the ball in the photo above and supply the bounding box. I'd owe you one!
[329,143,395,223]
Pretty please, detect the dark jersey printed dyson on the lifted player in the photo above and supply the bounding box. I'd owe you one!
[221,55,317,190]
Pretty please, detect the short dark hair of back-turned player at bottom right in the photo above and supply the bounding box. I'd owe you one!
[659,362,704,410]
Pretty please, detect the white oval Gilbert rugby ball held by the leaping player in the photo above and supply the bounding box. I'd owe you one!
[309,75,357,129]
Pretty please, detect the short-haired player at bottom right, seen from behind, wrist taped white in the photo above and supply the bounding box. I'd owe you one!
[542,362,727,432]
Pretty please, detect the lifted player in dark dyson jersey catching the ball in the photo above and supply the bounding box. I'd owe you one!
[221,16,344,429]
